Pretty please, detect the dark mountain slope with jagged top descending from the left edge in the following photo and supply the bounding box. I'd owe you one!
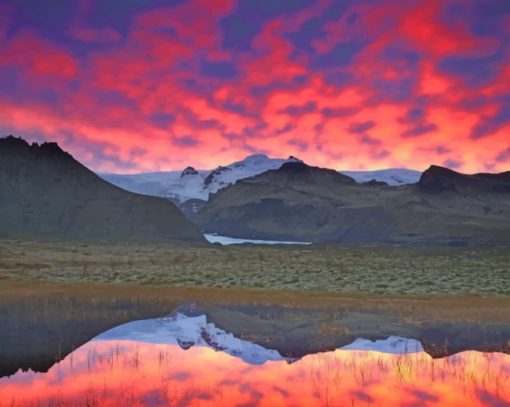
[0,136,204,242]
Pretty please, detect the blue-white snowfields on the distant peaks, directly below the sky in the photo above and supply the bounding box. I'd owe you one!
[100,154,421,204]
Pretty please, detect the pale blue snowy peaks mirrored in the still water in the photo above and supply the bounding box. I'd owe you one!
[93,312,423,365]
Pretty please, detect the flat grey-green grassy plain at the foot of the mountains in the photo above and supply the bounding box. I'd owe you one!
[0,240,510,296]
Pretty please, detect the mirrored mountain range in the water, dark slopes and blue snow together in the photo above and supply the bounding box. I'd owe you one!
[0,297,510,377]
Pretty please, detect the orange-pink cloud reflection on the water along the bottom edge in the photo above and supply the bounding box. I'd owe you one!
[0,340,510,406]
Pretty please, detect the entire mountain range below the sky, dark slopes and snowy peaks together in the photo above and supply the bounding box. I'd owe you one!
[0,136,510,246]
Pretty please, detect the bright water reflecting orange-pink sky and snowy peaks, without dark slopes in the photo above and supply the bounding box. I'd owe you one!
[0,314,510,407]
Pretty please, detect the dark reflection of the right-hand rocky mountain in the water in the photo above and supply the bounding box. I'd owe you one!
[175,303,510,359]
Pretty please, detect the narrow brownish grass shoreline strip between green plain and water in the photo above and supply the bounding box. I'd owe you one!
[0,280,510,324]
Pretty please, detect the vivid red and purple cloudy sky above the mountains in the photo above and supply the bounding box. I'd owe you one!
[0,0,510,173]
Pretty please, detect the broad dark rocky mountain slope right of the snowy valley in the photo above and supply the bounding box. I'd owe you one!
[192,163,510,245]
